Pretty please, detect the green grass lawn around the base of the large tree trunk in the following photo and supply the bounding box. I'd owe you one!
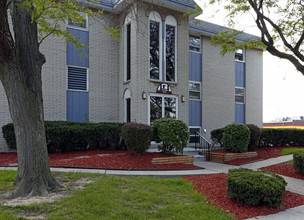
[0,171,234,220]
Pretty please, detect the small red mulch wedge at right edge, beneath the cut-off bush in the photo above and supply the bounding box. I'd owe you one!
[261,163,304,180]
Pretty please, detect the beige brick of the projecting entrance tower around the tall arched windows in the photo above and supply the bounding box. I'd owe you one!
[119,4,189,123]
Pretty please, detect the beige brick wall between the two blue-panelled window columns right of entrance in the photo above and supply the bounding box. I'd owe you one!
[202,38,235,138]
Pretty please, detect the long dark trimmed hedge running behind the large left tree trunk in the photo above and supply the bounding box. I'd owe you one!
[2,121,124,153]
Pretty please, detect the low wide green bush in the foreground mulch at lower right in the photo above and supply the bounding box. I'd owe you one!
[227,168,287,207]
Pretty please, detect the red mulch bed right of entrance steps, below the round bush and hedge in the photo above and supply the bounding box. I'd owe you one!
[214,146,303,165]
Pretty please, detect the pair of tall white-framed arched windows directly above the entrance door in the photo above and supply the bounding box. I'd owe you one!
[149,11,177,82]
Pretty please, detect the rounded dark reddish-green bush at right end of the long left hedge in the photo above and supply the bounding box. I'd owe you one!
[122,122,152,154]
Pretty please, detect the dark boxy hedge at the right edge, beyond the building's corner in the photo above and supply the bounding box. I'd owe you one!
[259,128,304,147]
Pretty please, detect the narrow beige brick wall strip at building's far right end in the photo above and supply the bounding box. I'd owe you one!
[245,50,263,127]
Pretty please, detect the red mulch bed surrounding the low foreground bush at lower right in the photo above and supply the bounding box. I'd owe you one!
[183,174,304,219]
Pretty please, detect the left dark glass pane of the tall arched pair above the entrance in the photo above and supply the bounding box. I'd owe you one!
[150,21,160,80]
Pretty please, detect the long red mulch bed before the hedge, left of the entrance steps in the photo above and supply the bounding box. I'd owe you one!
[0,150,200,170]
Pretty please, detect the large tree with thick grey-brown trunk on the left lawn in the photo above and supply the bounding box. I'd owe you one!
[0,0,105,196]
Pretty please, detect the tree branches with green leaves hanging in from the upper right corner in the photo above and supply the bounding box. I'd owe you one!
[205,0,304,75]
